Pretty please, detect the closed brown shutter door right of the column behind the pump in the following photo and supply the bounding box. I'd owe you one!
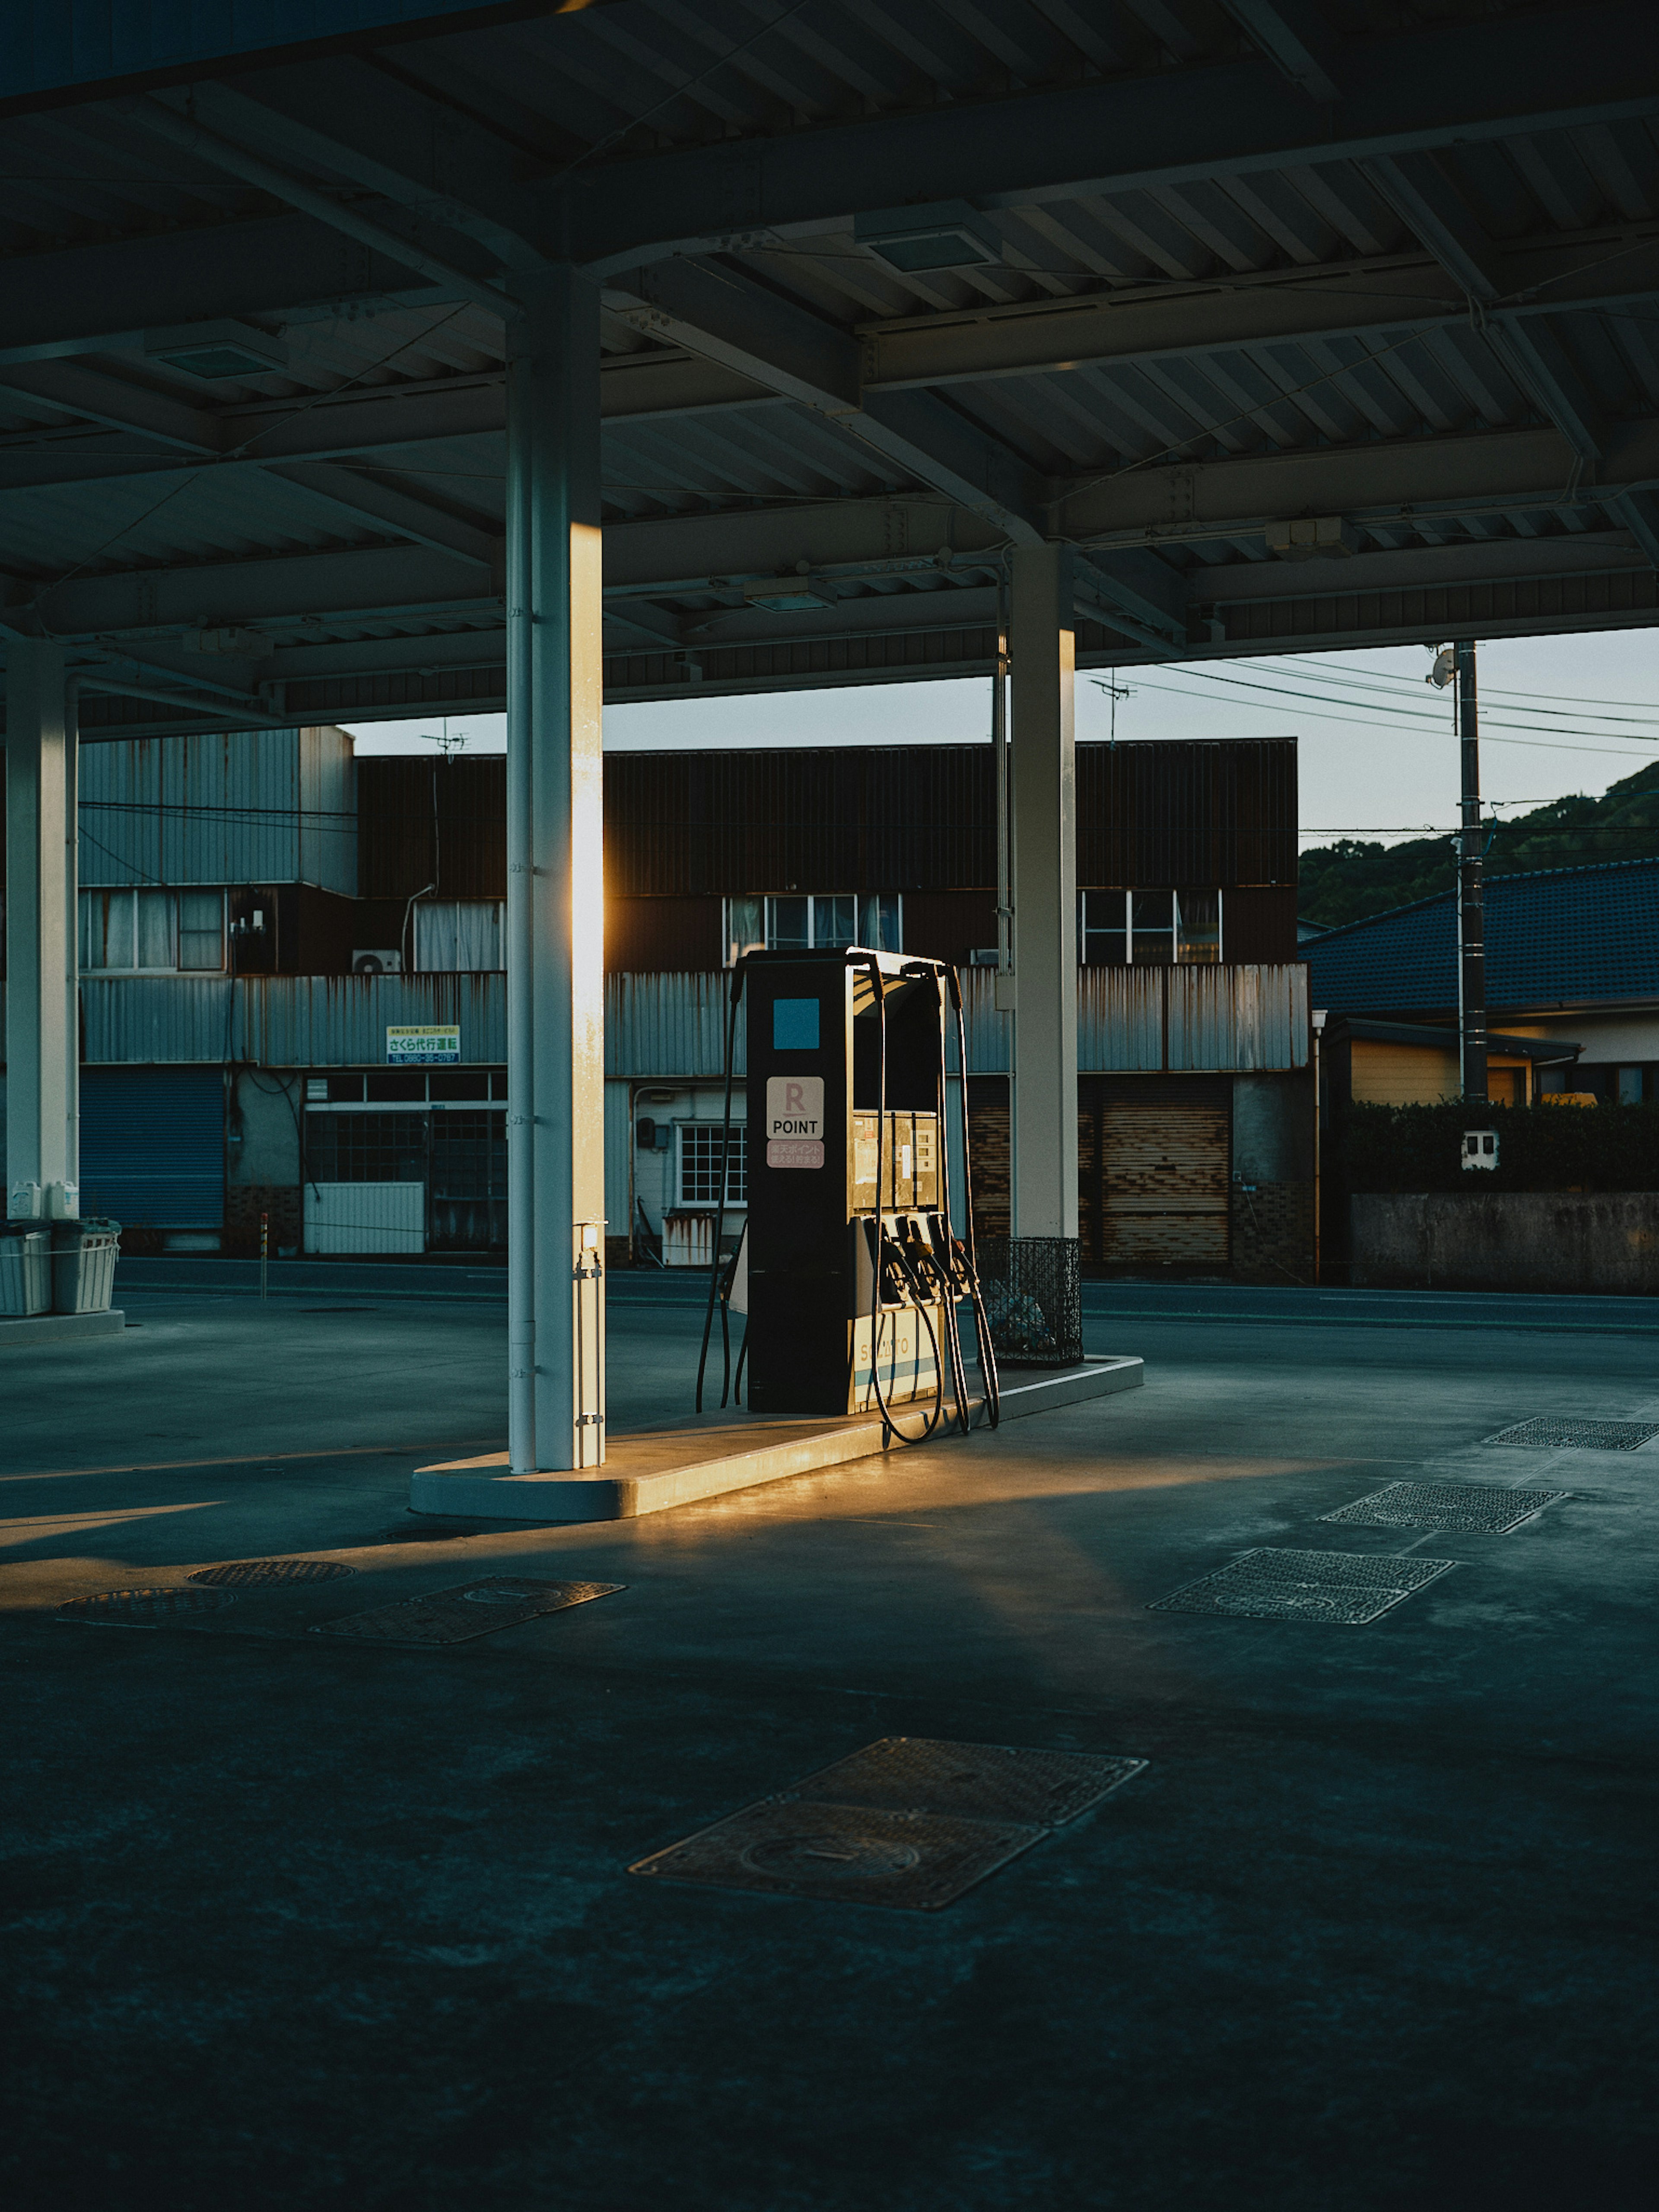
[1080,1084,1232,1268]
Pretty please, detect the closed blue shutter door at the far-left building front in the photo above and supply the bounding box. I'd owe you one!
[79,1068,226,1230]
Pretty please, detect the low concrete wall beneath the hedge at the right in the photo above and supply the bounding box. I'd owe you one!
[1349,1190,1659,1296]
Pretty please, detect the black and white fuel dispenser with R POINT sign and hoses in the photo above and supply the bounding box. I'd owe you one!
[697,947,998,1440]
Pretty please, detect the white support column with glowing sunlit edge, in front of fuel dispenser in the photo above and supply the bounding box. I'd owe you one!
[506,270,604,1473]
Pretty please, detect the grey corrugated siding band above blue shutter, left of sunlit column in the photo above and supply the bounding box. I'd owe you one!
[79,976,506,1068]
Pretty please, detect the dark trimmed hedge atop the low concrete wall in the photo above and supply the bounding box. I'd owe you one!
[1332,1100,1659,1192]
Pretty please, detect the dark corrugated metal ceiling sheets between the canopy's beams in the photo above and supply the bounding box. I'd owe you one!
[0,0,1659,721]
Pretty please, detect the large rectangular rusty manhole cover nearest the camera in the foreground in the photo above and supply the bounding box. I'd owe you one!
[628,1799,1049,1911]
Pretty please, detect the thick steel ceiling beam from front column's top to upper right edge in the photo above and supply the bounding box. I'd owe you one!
[566,0,1659,274]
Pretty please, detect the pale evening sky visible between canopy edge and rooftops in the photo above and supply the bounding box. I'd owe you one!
[340,630,1659,845]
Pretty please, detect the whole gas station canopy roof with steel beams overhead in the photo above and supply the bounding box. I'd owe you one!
[0,0,1659,739]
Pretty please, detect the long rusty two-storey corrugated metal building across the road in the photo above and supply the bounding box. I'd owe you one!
[6,728,1312,1281]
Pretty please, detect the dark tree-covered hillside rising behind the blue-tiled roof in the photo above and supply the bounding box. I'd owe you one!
[1296,761,1659,929]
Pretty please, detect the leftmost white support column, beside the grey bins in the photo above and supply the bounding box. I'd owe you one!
[6,639,77,1217]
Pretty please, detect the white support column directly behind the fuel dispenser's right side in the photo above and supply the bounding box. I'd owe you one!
[1009,547,1077,1239]
